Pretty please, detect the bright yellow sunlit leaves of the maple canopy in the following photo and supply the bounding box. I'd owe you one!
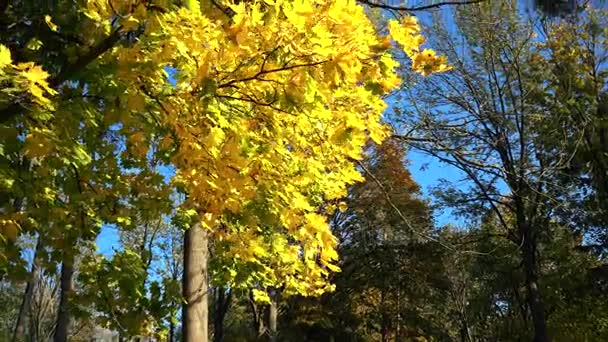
[0,0,448,295]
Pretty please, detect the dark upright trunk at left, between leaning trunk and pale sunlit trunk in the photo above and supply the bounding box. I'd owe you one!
[53,255,74,342]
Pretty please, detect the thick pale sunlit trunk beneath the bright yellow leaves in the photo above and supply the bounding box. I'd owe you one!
[182,223,209,342]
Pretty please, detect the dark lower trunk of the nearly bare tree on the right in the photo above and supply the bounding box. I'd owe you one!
[522,227,551,342]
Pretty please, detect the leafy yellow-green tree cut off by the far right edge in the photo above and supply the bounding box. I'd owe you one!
[538,9,608,254]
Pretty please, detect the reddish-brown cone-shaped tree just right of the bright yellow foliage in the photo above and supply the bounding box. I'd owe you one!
[280,140,450,341]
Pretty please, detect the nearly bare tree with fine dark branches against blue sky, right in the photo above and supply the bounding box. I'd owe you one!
[399,2,608,341]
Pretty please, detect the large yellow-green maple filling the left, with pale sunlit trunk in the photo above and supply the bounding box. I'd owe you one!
[0,0,449,341]
